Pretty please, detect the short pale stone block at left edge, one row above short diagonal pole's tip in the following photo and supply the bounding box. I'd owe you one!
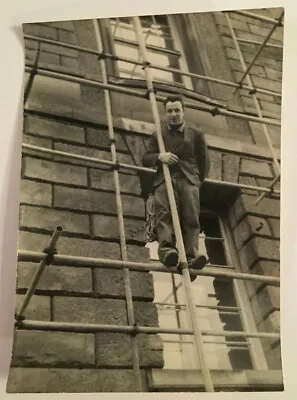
[20,179,52,207]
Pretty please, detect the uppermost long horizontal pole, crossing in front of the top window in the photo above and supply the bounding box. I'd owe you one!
[24,35,282,97]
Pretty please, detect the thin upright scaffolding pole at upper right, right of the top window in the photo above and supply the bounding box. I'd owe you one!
[225,12,280,203]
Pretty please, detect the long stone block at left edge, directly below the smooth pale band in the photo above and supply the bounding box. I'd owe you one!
[26,116,85,143]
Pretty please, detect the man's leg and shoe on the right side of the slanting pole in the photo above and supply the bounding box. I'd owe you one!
[180,179,206,268]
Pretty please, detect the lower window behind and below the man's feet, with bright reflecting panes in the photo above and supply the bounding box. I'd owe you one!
[146,210,267,370]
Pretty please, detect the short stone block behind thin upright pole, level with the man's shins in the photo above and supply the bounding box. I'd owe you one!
[92,215,145,242]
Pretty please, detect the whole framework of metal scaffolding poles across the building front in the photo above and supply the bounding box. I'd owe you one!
[15,11,283,392]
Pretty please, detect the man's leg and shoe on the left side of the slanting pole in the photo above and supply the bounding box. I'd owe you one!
[155,181,178,266]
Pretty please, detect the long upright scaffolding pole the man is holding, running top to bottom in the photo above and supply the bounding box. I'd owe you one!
[133,17,214,392]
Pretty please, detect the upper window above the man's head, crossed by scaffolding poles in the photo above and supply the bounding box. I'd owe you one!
[109,15,191,89]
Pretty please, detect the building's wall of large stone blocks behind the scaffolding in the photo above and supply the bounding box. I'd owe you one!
[8,8,281,392]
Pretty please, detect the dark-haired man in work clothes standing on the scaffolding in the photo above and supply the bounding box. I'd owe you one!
[142,96,210,273]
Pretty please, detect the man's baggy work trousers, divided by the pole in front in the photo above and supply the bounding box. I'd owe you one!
[155,172,200,262]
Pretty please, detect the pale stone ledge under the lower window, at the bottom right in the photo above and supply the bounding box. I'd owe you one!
[148,369,284,392]
